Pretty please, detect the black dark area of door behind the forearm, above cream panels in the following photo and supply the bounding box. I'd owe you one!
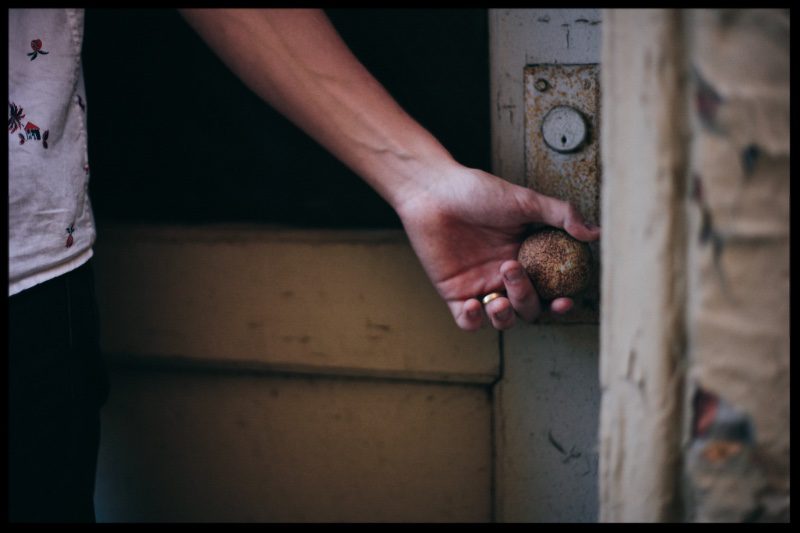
[83,9,490,228]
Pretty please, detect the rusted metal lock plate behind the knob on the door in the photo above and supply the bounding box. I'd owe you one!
[525,64,600,323]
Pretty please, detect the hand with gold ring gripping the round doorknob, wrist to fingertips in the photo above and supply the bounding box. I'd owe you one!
[396,166,600,331]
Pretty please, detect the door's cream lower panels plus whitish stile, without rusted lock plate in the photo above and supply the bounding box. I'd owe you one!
[90,10,601,522]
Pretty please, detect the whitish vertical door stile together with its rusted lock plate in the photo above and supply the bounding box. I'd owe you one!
[489,9,602,522]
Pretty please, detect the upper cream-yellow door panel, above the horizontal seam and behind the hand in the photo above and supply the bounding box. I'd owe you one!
[90,225,499,383]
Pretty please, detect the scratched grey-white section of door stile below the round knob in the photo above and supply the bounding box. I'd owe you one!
[495,325,600,522]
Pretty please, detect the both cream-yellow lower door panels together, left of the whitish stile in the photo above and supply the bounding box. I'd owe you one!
[96,226,500,522]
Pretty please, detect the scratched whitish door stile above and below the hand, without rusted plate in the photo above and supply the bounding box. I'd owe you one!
[489,9,603,522]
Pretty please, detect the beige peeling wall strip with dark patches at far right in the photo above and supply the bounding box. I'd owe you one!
[686,10,790,521]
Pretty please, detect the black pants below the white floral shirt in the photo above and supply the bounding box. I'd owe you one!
[8,264,108,522]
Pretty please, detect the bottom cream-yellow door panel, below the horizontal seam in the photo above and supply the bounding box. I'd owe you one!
[97,368,492,523]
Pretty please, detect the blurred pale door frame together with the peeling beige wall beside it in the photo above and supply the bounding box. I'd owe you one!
[600,10,790,522]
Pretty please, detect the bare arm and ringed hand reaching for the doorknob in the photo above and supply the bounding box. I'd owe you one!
[177,9,598,329]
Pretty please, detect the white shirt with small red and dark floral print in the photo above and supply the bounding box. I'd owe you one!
[8,9,95,295]
